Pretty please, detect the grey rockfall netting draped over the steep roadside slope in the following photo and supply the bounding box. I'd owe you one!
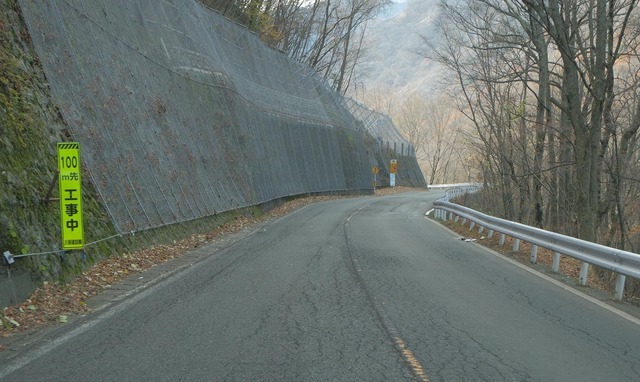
[19,0,425,233]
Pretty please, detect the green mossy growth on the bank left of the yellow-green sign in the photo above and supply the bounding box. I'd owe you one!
[0,1,61,268]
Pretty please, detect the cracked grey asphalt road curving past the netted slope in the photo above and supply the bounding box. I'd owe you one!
[0,191,640,381]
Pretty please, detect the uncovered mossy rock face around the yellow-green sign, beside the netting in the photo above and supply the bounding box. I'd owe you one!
[0,1,121,306]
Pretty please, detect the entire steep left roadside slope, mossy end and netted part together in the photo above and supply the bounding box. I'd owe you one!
[0,0,424,308]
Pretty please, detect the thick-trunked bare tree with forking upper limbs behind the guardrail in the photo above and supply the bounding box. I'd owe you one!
[522,0,637,241]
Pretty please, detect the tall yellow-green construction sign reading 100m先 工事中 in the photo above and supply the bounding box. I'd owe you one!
[58,142,84,250]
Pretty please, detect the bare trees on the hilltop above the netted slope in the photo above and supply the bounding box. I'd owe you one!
[199,0,392,94]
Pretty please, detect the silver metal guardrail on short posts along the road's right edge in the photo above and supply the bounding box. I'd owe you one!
[433,190,640,300]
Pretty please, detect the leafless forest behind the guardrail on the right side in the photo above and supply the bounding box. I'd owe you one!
[425,0,640,296]
